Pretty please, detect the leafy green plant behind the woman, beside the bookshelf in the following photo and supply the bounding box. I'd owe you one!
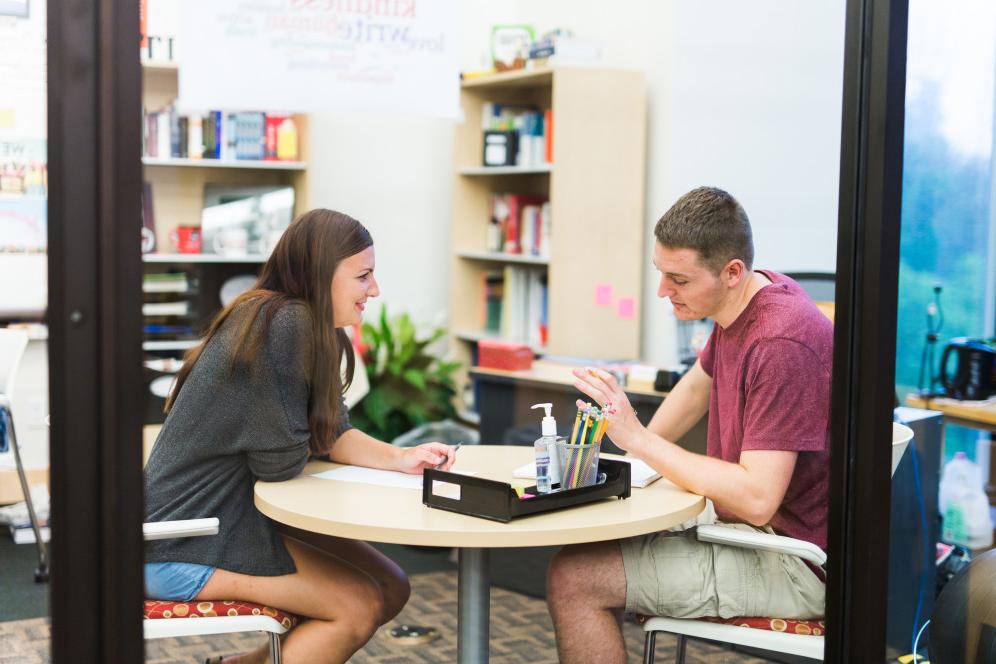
[349,306,460,441]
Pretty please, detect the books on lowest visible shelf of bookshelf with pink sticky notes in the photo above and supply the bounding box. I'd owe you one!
[483,265,549,347]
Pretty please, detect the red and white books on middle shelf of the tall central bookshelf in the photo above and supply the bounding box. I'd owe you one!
[486,194,550,258]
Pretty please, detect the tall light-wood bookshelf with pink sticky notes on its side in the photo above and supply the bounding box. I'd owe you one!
[449,67,647,404]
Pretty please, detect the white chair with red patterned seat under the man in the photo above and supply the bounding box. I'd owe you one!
[643,422,913,664]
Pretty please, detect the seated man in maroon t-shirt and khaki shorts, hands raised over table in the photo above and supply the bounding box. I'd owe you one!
[547,187,833,664]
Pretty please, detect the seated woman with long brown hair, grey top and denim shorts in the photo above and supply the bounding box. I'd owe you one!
[145,209,454,664]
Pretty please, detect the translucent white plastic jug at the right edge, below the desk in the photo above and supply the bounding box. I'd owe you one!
[938,452,993,549]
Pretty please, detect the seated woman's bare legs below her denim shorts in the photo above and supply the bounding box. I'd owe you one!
[196,537,385,664]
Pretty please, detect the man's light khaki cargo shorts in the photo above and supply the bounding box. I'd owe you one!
[619,523,826,620]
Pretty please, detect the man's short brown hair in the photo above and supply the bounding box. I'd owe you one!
[654,187,754,274]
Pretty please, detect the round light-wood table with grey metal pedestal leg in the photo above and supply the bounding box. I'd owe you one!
[255,445,705,663]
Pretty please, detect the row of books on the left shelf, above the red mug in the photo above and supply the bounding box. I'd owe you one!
[142,106,299,161]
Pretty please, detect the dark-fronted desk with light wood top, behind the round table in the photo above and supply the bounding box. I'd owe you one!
[470,360,707,454]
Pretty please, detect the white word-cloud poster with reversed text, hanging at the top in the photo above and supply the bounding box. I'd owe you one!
[177,0,459,118]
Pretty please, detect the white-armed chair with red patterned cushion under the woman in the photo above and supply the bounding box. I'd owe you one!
[143,518,297,664]
